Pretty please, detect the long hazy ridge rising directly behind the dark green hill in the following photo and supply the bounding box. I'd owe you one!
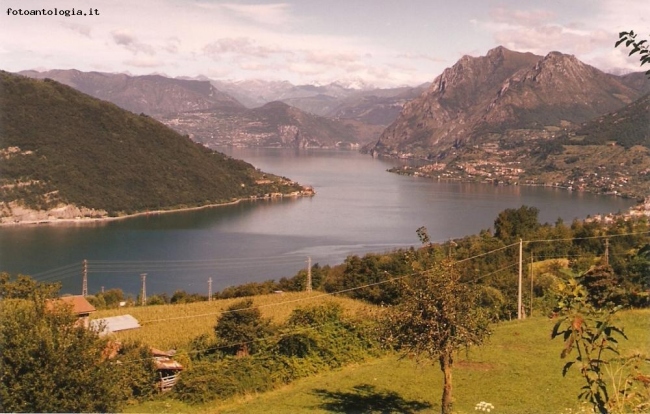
[20,69,243,116]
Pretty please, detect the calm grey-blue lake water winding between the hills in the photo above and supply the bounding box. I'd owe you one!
[0,149,634,295]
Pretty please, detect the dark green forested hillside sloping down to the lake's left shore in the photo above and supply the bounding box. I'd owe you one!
[0,72,300,215]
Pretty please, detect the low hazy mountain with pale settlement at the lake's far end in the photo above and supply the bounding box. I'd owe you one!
[161,102,380,148]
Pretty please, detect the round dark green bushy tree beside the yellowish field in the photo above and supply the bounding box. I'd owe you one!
[214,299,271,355]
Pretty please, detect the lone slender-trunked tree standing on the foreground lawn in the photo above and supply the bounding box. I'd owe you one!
[382,259,490,414]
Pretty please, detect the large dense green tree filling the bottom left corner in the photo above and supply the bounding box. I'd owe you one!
[0,298,125,412]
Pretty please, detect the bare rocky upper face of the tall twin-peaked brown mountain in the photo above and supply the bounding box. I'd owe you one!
[370,47,640,158]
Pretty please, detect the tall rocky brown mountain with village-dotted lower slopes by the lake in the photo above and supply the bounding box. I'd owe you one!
[374,47,650,197]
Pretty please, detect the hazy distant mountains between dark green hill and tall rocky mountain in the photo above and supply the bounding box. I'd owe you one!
[20,70,424,148]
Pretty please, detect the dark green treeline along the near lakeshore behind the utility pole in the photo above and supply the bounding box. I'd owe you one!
[184,206,650,319]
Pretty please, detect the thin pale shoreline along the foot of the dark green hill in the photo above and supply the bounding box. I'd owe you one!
[0,187,316,227]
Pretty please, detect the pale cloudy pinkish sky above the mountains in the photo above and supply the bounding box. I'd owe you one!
[0,0,650,87]
